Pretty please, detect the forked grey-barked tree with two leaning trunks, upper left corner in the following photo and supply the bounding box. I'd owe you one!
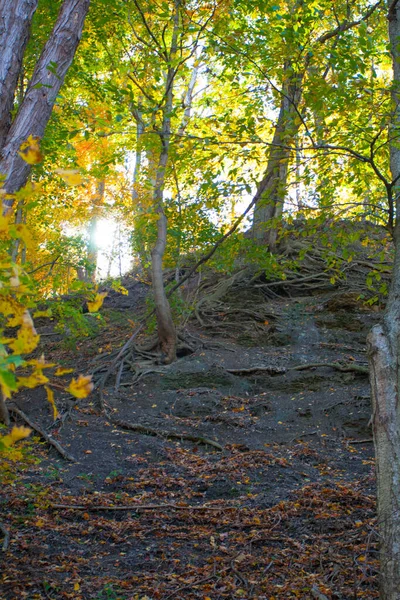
[0,0,90,206]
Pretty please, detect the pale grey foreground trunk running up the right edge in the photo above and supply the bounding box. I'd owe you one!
[368,0,400,600]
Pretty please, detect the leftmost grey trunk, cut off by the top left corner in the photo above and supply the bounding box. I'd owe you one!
[0,0,38,148]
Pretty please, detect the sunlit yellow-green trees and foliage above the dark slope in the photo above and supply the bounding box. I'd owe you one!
[0,0,400,599]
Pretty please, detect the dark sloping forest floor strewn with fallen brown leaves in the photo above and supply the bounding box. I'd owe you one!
[0,278,381,600]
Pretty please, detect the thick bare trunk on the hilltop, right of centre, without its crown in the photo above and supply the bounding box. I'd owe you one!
[252,63,304,252]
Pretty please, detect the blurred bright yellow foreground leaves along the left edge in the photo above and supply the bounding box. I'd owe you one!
[0,136,95,450]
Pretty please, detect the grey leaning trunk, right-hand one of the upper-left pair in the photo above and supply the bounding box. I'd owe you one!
[0,0,90,198]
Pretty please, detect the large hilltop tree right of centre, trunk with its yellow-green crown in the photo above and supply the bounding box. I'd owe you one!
[216,0,380,251]
